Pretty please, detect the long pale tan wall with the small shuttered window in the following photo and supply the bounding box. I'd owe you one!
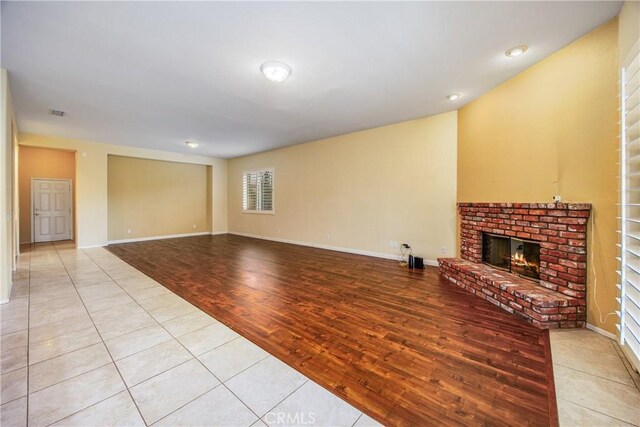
[229,112,456,260]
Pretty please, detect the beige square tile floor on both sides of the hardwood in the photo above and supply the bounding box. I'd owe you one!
[0,243,640,426]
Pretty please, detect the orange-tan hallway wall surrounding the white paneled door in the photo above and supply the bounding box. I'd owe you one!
[18,147,76,243]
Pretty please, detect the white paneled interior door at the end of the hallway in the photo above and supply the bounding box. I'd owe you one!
[32,179,71,242]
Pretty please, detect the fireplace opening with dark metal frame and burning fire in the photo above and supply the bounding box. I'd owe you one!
[482,233,540,281]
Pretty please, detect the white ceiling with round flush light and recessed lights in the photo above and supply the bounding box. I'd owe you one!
[1,1,622,158]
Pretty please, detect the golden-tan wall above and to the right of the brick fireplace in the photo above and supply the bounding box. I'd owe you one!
[458,20,618,333]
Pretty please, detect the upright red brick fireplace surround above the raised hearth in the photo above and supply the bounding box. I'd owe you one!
[458,203,591,299]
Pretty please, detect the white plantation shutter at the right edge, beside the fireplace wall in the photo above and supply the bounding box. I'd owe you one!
[617,39,640,368]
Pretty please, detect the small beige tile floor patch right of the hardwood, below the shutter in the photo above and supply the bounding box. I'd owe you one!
[551,329,640,426]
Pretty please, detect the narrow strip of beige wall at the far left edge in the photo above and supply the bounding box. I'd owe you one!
[0,69,18,303]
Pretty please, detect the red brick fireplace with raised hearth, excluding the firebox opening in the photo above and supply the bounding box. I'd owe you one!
[438,203,591,328]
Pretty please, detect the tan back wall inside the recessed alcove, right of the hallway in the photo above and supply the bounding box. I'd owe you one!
[107,156,211,241]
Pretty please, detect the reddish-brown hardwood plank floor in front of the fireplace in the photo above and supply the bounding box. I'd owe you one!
[108,235,557,426]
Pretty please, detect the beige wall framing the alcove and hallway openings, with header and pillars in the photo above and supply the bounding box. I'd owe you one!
[19,134,227,247]
